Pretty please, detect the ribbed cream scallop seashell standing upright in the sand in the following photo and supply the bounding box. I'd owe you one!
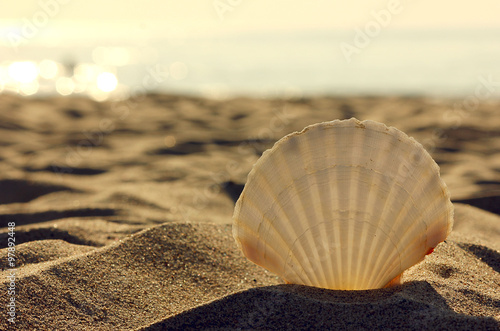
[233,118,453,290]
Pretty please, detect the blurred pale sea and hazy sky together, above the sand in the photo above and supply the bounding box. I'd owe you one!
[0,0,500,101]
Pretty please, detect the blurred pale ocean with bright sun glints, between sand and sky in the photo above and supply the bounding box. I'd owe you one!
[0,30,500,100]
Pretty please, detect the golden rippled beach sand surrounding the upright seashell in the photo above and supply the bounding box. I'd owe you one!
[0,95,500,330]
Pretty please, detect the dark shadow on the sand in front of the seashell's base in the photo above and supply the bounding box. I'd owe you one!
[143,281,499,330]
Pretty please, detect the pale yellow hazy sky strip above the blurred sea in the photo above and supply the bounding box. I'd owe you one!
[0,0,500,36]
